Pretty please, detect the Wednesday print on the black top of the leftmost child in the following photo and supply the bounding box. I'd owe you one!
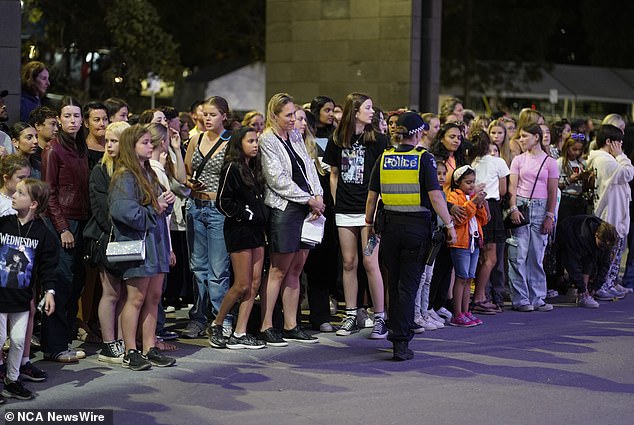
[0,233,38,289]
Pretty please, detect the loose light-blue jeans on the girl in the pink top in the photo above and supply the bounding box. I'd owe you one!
[506,196,548,307]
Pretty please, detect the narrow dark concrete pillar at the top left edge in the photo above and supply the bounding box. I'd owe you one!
[0,0,22,125]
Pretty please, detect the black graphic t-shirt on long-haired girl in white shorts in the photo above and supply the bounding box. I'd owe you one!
[324,133,388,214]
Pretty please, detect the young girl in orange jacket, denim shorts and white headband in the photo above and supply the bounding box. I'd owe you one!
[447,165,489,327]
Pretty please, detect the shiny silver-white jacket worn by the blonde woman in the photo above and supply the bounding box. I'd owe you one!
[260,128,324,211]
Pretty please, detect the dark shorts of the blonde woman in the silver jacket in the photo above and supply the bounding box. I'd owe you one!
[267,202,312,254]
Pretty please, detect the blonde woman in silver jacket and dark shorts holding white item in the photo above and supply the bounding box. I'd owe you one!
[259,93,325,347]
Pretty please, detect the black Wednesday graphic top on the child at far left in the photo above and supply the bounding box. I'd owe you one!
[0,215,59,313]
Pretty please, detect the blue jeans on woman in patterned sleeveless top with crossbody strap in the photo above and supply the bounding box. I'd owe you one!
[186,199,230,324]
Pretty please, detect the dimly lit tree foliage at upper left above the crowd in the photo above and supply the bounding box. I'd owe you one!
[24,0,181,98]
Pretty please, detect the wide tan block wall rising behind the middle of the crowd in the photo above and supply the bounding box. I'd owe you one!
[266,0,422,109]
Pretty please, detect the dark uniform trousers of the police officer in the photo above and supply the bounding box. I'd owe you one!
[381,211,431,342]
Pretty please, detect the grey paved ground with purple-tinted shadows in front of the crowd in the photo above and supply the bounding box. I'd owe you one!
[3,296,634,425]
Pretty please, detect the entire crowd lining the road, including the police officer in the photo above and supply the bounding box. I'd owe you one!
[0,62,634,401]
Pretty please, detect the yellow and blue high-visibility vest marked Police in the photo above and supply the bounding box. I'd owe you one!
[380,149,429,212]
